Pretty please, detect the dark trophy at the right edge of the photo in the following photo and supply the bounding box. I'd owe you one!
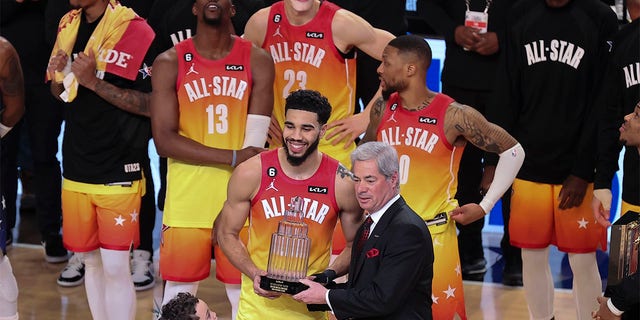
[607,211,640,285]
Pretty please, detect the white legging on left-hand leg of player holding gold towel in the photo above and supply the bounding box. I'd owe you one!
[84,250,107,320]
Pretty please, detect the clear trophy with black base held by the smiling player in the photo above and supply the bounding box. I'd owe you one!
[260,196,311,294]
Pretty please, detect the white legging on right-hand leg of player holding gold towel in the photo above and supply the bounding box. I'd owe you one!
[100,248,136,320]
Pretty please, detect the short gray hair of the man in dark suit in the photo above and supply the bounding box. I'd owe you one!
[351,141,400,190]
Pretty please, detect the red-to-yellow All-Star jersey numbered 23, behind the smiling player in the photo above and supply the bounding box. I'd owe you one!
[262,1,356,167]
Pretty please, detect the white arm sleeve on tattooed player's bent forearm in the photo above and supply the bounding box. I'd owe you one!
[479,143,524,214]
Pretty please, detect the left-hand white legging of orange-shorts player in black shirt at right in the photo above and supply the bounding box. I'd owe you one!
[522,247,552,320]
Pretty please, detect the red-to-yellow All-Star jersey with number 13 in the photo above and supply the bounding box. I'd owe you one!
[163,37,252,228]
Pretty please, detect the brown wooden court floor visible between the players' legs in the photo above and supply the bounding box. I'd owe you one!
[8,244,577,320]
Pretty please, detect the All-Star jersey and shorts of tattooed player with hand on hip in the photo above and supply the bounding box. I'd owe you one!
[377,93,466,319]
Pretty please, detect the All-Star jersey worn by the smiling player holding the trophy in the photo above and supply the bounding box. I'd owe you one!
[238,149,339,319]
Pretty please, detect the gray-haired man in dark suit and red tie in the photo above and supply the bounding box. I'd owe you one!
[293,142,433,319]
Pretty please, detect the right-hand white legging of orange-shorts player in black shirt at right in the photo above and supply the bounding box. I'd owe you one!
[569,252,602,320]
